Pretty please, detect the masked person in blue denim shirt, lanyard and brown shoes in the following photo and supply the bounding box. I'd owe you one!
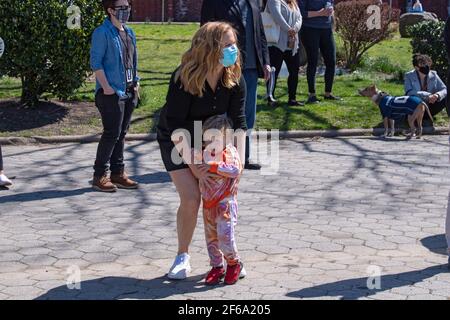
[91,0,139,192]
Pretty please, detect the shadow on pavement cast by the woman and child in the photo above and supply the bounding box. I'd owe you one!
[35,275,215,300]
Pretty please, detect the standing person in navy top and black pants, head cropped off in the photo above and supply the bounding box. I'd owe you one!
[300,0,341,103]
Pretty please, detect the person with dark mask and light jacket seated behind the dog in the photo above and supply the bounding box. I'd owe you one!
[405,54,450,120]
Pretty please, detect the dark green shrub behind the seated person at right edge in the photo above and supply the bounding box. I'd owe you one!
[408,21,449,79]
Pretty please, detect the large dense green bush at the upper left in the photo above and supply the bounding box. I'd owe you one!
[0,0,103,106]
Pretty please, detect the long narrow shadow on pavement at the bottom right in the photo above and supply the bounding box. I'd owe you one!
[286,264,449,300]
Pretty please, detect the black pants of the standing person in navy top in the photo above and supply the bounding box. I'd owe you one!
[300,27,336,93]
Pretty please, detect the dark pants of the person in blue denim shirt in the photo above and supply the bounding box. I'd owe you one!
[94,89,136,177]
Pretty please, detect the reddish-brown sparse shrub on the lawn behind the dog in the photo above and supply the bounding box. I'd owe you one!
[335,0,400,70]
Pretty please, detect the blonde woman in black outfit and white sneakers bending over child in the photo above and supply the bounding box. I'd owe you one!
[157,22,247,279]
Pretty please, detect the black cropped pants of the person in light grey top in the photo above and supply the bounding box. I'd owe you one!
[269,46,300,101]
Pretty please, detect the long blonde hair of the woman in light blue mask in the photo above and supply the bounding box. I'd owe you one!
[175,22,242,97]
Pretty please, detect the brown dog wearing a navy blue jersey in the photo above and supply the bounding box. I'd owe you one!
[358,85,433,139]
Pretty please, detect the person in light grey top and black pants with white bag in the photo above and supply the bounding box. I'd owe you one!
[266,0,303,106]
